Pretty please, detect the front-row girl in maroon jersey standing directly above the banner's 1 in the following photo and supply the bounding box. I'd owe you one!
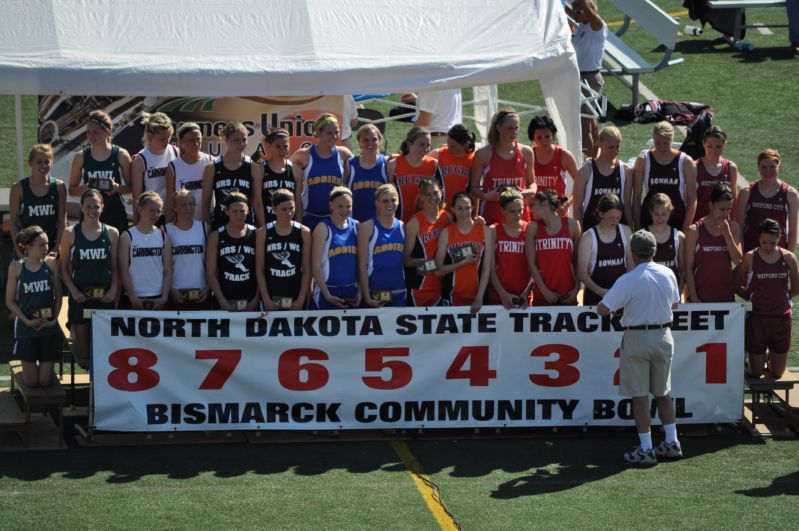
[685,183,741,302]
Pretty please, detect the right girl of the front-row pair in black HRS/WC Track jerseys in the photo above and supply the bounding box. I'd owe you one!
[255,188,311,311]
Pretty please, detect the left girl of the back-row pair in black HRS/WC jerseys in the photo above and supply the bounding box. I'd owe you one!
[202,122,264,230]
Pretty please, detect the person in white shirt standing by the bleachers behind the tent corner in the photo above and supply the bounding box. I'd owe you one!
[565,0,608,158]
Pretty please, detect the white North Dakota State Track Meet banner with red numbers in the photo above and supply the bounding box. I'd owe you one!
[92,304,744,431]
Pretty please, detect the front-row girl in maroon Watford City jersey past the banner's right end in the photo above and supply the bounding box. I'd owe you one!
[735,219,799,379]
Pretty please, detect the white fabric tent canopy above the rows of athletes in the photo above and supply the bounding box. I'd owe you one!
[0,0,580,158]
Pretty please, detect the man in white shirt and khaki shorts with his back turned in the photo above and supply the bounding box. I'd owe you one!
[597,230,682,465]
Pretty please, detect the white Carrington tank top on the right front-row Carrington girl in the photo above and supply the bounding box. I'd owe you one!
[166,220,206,289]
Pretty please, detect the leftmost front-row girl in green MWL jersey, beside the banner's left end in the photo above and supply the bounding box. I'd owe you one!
[6,225,61,387]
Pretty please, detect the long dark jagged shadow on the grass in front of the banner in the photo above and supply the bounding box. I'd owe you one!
[0,436,764,490]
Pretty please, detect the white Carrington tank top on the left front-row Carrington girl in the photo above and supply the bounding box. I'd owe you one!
[128,226,164,297]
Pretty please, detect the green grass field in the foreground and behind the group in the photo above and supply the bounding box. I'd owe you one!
[0,0,799,529]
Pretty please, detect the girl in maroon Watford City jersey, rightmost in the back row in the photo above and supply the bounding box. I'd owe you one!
[735,149,799,252]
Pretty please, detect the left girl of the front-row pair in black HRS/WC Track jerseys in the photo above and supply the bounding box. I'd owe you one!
[205,192,259,312]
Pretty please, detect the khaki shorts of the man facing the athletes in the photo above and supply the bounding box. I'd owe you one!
[619,328,674,397]
